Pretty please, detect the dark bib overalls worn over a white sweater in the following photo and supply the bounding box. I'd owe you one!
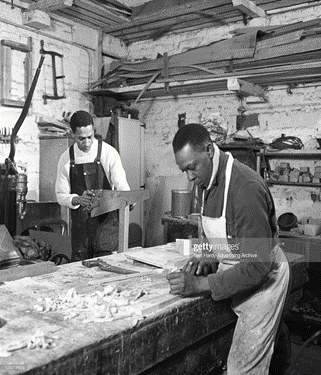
[69,140,118,261]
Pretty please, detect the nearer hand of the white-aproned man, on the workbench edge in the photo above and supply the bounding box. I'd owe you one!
[166,272,210,296]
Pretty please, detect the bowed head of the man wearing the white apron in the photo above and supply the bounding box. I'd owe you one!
[173,124,214,187]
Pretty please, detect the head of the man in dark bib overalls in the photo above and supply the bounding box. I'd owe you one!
[70,111,95,152]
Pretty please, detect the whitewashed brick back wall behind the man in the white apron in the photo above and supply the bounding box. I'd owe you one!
[123,5,321,245]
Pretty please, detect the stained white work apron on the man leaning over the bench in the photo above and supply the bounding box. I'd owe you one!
[201,154,289,375]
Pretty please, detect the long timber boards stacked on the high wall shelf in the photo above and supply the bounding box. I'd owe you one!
[89,19,321,101]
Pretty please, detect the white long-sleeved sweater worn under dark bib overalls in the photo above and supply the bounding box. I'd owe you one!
[55,139,130,209]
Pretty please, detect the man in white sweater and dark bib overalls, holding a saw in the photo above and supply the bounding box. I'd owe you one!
[56,111,130,261]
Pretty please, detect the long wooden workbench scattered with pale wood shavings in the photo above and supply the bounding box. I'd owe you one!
[0,245,236,375]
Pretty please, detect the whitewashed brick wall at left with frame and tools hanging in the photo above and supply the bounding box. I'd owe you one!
[0,3,98,201]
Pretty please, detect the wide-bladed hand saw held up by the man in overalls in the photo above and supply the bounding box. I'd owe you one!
[90,189,150,217]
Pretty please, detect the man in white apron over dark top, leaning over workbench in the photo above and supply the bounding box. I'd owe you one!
[167,124,289,375]
